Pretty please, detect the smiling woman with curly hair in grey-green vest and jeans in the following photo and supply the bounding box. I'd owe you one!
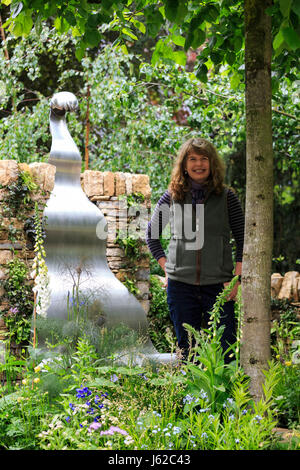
[147,138,244,363]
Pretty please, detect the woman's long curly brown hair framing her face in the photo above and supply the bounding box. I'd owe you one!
[168,138,225,201]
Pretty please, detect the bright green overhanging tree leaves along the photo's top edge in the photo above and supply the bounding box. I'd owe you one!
[2,0,300,76]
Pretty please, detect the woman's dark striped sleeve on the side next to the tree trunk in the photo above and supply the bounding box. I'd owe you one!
[227,189,245,261]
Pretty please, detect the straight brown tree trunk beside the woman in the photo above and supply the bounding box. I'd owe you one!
[241,0,273,401]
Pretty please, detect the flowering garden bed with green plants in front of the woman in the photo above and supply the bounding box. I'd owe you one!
[0,284,299,450]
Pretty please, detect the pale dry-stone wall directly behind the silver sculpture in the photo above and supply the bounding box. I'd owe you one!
[0,160,151,346]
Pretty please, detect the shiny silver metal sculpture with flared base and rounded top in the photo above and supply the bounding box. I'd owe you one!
[44,92,174,362]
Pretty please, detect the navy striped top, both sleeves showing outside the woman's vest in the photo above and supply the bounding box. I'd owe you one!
[146,189,245,262]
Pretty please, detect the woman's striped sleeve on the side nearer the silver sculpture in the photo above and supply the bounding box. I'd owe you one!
[146,191,171,260]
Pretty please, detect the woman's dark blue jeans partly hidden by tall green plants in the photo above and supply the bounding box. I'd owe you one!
[167,279,236,363]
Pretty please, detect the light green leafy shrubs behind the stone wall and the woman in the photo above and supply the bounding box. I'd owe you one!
[0,24,299,272]
